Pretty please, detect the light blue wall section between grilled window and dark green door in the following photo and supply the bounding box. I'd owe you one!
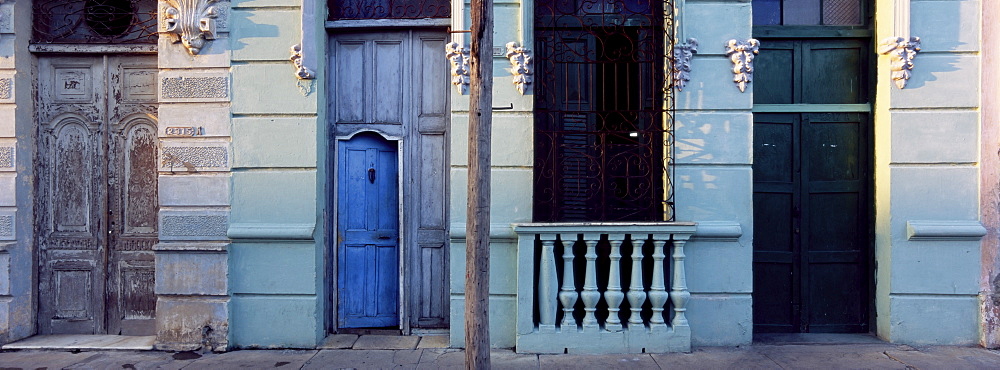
[674,0,753,346]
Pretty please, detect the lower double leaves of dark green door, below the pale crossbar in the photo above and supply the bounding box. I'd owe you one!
[753,113,869,333]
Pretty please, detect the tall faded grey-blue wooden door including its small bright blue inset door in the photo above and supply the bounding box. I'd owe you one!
[329,30,450,332]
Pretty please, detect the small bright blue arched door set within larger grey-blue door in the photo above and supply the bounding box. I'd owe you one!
[337,134,399,328]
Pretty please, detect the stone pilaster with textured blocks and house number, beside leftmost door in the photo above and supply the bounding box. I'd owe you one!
[155,0,233,351]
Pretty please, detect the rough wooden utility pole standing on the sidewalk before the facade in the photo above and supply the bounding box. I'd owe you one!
[465,0,493,369]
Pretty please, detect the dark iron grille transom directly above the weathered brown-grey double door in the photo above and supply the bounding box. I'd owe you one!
[32,0,157,44]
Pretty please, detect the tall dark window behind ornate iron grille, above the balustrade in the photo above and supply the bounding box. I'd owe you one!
[534,0,674,222]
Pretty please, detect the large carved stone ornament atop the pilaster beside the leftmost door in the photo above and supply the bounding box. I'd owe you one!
[164,0,219,55]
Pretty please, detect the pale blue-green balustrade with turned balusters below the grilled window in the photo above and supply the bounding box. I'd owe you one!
[514,222,695,353]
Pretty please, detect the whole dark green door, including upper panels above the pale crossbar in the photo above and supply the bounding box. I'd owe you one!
[753,38,871,333]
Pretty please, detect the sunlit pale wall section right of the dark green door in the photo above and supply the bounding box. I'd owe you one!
[875,0,981,345]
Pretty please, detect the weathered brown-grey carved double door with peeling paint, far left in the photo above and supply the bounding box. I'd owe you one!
[35,55,159,335]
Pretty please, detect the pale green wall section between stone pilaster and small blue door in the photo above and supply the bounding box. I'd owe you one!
[229,0,326,348]
